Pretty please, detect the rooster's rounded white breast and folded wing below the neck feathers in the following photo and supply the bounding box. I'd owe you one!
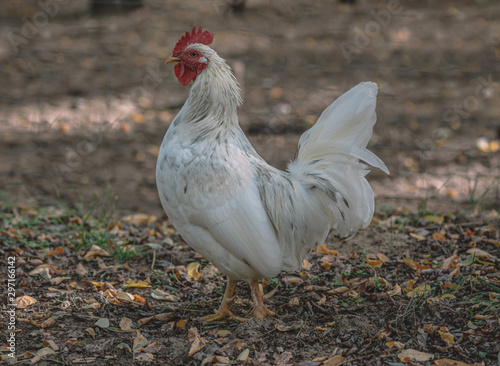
[157,133,283,281]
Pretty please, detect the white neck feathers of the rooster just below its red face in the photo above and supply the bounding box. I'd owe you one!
[185,44,242,128]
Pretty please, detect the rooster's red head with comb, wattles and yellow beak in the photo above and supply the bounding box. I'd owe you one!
[165,26,214,85]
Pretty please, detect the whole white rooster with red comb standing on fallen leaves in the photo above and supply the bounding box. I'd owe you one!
[156,27,389,321]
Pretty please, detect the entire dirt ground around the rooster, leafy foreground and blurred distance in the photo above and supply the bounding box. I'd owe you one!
[0,0,500,366]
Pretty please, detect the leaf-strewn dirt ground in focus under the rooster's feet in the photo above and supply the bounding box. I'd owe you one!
[0,204,500,366]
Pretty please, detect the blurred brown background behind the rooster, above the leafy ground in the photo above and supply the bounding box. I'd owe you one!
[0,0,500,215]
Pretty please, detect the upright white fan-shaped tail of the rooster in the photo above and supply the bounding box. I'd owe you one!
[288,82,389,236]
